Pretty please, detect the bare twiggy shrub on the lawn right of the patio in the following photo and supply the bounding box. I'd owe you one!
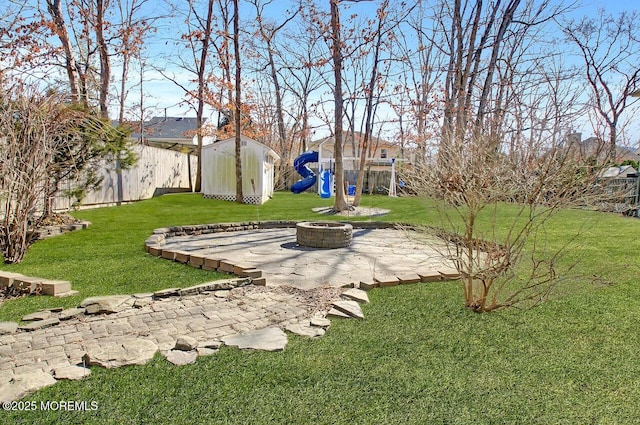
[403,135,600,312]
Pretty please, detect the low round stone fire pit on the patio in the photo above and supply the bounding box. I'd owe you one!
[296,221,353,249]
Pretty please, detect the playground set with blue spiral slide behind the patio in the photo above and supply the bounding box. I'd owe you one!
[291,151,397,198]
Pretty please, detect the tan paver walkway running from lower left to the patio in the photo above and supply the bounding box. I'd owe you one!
[0,285,348,401]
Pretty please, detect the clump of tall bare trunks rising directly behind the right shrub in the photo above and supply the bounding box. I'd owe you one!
[434,0,567,157]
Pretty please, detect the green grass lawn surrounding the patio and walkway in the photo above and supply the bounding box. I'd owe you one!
[0,193,640,424]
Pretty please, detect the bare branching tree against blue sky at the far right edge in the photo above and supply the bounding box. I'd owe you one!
[564,10,640,161]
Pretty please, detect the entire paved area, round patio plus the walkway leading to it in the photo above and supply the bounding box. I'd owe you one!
[0,222,457,401]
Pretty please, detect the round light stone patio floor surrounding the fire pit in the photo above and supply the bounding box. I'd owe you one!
[157,228,455,289]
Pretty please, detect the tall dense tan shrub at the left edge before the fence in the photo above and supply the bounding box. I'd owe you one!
[0,85,135,263]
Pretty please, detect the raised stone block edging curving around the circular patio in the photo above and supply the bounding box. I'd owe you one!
[145,220,460,290]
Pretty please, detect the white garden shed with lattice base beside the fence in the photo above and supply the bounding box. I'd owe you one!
[202,136,280,205]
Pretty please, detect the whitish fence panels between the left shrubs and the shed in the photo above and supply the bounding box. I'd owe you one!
[52,145,197,210]
